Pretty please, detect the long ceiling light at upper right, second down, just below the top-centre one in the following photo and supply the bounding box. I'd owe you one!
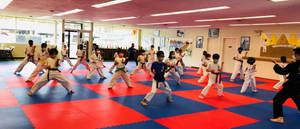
[195,15,276,22]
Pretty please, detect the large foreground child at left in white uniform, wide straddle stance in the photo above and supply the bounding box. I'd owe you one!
[28,48,75,96]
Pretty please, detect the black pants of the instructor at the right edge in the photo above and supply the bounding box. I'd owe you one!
[273,81,300,118]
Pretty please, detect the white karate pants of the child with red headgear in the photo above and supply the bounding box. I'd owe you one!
[108,71,131,87]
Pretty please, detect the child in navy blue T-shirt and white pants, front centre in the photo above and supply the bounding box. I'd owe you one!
[141,51,174,106]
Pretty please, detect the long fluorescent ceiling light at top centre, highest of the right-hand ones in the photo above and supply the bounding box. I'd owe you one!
[151,6,230,16]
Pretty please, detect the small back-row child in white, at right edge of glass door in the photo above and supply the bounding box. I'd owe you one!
[71,44,90,73]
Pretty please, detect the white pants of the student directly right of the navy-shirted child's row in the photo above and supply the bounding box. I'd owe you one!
[201,77,223,96]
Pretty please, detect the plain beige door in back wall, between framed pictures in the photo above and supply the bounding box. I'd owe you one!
[223,38,238,73]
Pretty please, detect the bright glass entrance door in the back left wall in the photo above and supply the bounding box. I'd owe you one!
[65,30,79,59]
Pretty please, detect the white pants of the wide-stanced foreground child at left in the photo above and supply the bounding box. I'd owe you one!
[30,71,72,94]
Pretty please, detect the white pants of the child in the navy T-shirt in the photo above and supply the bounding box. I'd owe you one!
[144,79,172,102]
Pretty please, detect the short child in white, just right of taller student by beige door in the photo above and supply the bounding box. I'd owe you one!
[241,57,257,93]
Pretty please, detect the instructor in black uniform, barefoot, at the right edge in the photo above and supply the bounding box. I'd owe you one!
[270,48,300,124]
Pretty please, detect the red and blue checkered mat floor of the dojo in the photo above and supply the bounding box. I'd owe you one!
[0,61,300,129]
